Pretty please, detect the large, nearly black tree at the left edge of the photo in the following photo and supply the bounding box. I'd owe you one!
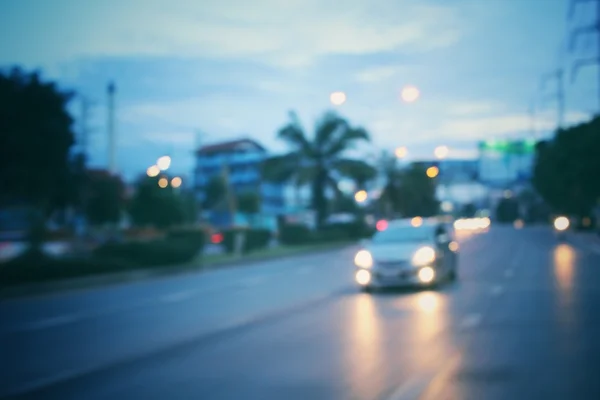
[0,68,74,213]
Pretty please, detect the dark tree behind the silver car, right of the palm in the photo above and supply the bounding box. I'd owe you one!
[393,164,439,217]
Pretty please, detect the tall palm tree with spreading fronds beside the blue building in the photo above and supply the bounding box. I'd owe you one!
[263,112,375,227]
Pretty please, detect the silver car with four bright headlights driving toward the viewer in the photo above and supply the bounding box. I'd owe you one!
[354,217,458,290]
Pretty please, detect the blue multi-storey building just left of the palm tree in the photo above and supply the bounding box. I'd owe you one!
[194,139,285,228]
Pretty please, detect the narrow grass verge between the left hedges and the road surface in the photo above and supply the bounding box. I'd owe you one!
[0,241,355,299]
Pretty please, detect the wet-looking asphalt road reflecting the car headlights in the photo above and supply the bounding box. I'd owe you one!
[0,227,600,400]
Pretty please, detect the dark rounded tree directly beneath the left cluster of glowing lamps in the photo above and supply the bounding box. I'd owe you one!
[130,178,185,229]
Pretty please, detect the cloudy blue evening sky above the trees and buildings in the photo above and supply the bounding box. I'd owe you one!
[0,0,598,178]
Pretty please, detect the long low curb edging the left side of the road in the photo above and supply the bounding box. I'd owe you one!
[0,243,354,302]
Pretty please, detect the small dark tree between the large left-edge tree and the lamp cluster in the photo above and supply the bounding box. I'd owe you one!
[85,171,125,225]
